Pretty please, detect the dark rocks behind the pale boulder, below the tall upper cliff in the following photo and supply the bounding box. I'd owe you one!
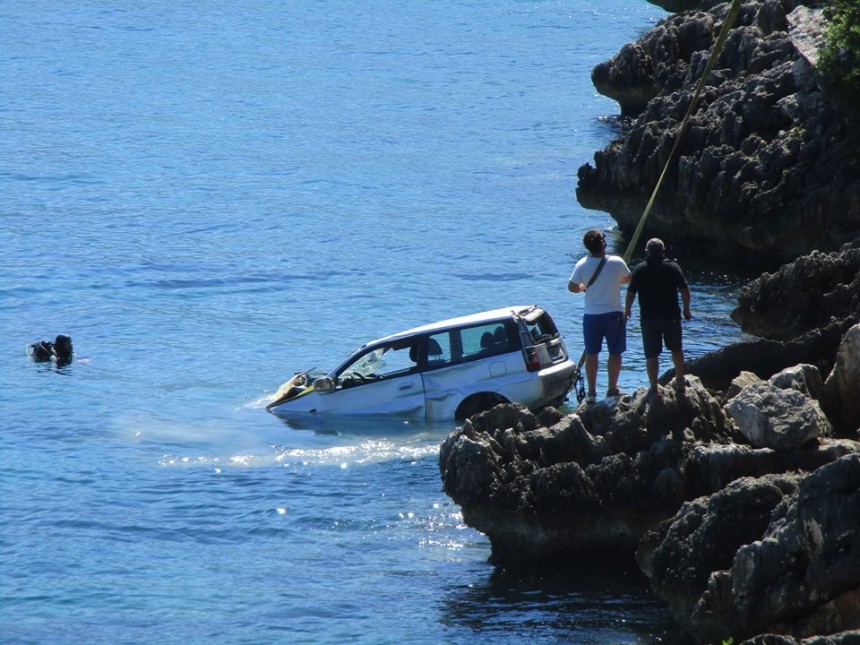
[680,239,860,438]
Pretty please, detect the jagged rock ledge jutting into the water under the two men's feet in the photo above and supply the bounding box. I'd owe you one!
[439,378,858,563]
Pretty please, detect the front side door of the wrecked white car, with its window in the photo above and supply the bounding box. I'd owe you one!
[318,340,424,419]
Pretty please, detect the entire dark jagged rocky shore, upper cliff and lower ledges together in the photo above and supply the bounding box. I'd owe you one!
[439,0,860,645]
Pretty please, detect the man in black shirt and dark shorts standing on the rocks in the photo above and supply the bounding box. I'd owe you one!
[624,237,693,399]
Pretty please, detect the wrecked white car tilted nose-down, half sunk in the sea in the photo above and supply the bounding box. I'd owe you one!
[266,305,577,421]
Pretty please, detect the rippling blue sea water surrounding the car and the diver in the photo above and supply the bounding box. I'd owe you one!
[0,0,752,644]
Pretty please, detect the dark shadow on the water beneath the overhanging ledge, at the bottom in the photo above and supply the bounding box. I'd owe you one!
[441,558,685,644]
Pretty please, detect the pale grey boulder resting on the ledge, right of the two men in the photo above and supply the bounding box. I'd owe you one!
[726,383,833,451]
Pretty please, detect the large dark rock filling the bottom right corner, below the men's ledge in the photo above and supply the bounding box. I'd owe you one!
[636,454,860,643]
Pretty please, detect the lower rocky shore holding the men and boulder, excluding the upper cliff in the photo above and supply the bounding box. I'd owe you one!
[439,240,860,645]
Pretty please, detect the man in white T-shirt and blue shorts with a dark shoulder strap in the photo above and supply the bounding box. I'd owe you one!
[567,229,630,403]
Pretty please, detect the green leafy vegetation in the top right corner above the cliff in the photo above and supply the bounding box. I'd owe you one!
[819,0,860,105]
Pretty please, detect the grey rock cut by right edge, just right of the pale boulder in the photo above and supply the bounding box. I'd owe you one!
[823,324,860,437]
